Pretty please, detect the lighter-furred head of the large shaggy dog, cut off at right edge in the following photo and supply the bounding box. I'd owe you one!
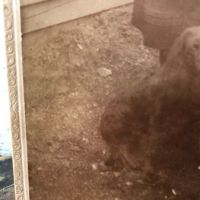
[167,26,200,72]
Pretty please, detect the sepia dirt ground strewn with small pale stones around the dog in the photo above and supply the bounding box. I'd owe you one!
[23,6,200,200]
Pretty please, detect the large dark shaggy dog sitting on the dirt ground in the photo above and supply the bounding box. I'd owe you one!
[101,27,200,175]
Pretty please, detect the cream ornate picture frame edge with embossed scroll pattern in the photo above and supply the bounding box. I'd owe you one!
[0,0,29,200]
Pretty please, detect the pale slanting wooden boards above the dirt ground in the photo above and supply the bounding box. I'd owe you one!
[22,0,133,33]
